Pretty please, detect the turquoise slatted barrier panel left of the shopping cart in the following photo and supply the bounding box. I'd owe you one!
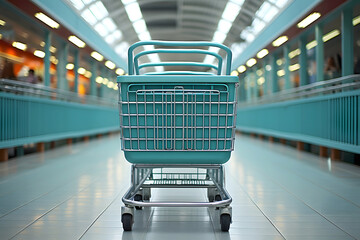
[0,93,119,148]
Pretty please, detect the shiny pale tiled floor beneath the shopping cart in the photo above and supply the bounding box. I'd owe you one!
[0,135,360,240]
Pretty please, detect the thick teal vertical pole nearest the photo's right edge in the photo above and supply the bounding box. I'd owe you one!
[341,6,354,76]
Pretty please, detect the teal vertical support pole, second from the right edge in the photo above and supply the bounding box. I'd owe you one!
[315,24,324,82]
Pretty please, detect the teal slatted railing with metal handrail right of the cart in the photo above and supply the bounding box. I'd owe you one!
[237,75,360,153]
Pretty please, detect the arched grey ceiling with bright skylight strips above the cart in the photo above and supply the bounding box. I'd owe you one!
[65,0,291,71]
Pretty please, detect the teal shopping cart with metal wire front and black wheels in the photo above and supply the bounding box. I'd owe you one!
[117,41,238,231]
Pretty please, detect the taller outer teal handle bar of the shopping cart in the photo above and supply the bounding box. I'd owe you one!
[128,41,232,75]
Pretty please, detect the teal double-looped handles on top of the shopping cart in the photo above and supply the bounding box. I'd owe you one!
[128,41,232,75]
